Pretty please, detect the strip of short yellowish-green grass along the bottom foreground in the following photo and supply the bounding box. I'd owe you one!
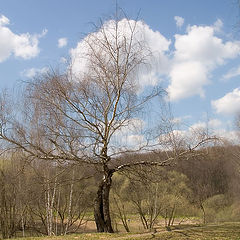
[9,223,240,240]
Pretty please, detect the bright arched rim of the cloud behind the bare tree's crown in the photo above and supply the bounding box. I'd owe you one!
[70,19,171,88]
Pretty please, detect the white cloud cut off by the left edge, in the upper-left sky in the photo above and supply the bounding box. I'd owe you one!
[0,15,47,62]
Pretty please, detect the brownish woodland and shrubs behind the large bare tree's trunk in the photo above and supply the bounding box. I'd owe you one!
[0,146,240,238]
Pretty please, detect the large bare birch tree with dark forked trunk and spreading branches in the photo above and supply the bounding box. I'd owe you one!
[0,14,213,232]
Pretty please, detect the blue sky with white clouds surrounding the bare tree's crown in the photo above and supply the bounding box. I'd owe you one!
[0,0,240,141]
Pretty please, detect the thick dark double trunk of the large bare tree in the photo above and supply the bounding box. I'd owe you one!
[94,167,114,233]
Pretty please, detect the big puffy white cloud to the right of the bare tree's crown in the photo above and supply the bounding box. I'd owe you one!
[168,23,240,101]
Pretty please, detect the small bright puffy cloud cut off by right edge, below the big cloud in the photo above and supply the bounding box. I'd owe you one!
[211,88,240,115]
